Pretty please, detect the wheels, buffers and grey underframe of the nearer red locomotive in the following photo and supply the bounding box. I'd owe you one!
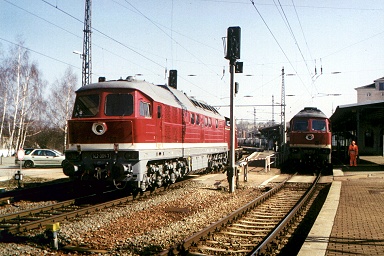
[63,148,228,190]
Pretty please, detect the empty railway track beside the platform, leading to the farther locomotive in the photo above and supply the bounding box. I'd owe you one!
[161,173,320,255]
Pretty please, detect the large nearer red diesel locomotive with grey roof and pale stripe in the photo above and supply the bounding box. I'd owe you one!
[63,77,234,191]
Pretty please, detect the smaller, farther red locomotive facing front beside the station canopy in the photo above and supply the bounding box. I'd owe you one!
[288,107,332,171]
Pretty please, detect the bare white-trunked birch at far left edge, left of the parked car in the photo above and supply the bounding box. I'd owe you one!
[0,42,44,153]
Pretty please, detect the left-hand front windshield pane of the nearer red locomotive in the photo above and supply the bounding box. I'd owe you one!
[73,94,100,117]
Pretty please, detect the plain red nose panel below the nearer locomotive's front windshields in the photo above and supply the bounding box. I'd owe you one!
[68,120,133,144]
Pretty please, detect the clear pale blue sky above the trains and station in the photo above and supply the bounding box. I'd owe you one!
[0,0,384,122]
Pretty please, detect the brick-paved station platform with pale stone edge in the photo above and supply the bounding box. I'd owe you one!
[299,156,384,256]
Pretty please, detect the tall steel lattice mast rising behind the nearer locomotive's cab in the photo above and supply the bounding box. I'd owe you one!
[81,0,92,86]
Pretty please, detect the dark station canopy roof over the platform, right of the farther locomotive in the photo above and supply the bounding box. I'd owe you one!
[330,101,384,132]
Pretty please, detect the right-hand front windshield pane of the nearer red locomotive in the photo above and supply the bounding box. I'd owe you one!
[105,94,133,116]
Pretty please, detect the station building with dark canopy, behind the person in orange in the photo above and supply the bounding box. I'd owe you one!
[330,77,384,160]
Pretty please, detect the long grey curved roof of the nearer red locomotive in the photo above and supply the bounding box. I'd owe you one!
[76,78,221,117]
